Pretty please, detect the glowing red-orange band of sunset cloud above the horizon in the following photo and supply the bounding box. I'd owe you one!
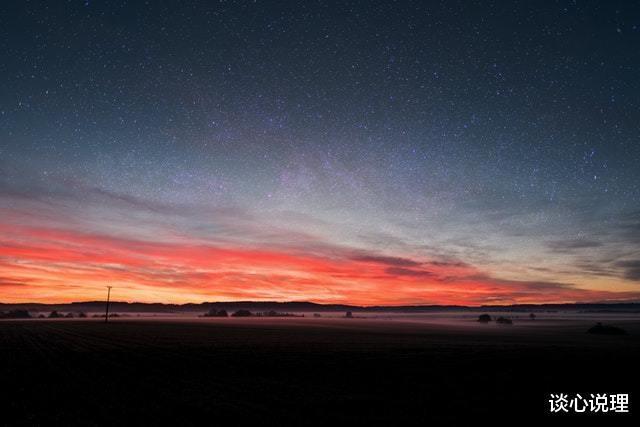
[0,224,638,305]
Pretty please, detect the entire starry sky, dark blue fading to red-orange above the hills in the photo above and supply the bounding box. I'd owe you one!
[0,0,640,305]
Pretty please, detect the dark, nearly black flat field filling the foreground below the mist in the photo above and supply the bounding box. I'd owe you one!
[0,319,640,426]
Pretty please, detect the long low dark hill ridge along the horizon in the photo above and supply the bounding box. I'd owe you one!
[0,301,640,313]
